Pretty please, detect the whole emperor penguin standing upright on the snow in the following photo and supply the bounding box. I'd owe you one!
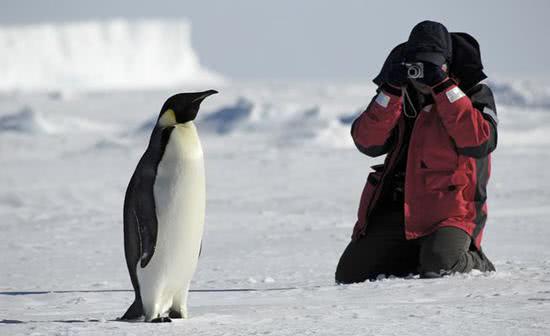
[121,90,218,322]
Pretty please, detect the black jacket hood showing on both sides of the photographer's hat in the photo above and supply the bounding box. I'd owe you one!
[372,33,487,92]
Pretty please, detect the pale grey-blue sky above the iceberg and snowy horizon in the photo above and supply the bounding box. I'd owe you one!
[0,0,550,80]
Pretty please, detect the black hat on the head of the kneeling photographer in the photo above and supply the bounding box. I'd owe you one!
[405,21,453,65]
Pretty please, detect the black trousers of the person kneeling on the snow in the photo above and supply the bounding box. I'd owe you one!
[336,204,495,284]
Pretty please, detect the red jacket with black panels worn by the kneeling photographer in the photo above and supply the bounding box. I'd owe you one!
[351,80,498,248]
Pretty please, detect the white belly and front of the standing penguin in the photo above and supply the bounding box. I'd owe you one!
[136,122,205,320]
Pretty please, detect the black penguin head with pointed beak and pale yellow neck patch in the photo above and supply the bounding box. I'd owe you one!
[157,90,218,127]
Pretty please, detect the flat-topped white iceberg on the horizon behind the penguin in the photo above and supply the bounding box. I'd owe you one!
[0,19,221,91]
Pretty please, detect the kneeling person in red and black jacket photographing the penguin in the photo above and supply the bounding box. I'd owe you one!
[336,21,498,283]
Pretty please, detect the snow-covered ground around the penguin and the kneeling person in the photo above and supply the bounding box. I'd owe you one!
[0,83,550,335]
